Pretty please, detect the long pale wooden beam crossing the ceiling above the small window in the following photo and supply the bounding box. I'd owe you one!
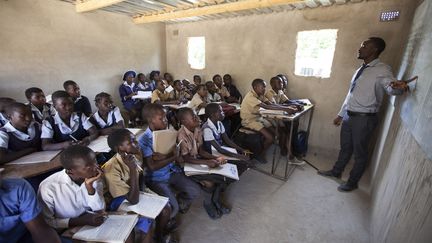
[133,0,305,24]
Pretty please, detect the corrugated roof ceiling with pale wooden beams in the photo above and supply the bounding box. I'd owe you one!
[60,0,363,24]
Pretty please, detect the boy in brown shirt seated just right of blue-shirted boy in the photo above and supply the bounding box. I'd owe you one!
[177,107,231,219]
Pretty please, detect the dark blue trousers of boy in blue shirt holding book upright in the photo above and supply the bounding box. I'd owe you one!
[147,172,200,217]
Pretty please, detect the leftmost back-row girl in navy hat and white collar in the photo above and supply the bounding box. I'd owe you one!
[119,71,142,127]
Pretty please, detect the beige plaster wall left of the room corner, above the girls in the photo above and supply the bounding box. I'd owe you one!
[0,0,166,108]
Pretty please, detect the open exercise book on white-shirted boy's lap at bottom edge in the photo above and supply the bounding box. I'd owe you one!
[72,214,138,243]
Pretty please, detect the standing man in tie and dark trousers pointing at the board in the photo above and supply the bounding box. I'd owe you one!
[318,37,408,192]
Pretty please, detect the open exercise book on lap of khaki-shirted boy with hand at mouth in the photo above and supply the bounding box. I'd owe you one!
[118,192,168,219]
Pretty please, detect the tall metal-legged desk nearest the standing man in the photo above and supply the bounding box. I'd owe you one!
[256,100,314,181]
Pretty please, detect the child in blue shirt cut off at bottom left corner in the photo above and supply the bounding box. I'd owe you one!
[0,168,60,243]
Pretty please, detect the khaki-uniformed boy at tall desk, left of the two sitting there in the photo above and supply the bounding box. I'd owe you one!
[240,79,297,162]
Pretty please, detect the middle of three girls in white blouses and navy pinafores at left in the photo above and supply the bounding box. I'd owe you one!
[41,90,98,150]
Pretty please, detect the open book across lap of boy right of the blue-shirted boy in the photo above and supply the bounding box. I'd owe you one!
[184,163,239,180]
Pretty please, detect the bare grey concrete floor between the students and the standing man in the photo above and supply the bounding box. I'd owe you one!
[179,150,370,243]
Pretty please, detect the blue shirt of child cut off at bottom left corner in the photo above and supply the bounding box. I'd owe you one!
[0,179,41,242]
